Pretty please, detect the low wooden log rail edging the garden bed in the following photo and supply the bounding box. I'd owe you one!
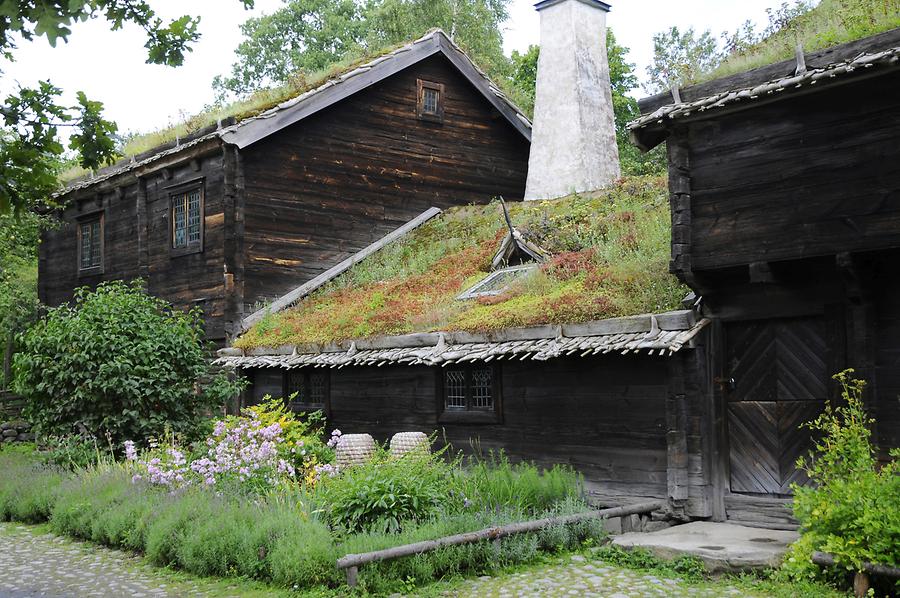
[337,501,666,586]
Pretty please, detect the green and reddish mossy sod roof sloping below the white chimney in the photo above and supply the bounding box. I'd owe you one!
[235,177,688,348]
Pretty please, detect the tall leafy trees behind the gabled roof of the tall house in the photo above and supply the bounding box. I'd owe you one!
[213,0,509,99]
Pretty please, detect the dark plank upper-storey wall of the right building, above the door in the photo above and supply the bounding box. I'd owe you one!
[683,73,900,271]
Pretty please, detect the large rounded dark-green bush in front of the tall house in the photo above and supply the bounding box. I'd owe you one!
[14,281,236,444]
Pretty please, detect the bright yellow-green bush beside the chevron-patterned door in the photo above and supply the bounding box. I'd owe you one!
[786,370,900,592]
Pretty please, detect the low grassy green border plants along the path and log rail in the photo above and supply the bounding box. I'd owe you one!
[0,450,603,595]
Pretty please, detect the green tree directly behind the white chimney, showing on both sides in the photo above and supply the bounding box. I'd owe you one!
[511,29,666,175]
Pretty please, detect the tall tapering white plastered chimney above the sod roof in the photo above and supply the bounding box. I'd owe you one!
[525,0,619,199]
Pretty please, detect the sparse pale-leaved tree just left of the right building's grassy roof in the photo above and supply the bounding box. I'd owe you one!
[647,27,722,93]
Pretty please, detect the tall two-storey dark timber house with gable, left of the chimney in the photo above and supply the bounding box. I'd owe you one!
[39,31,531,343]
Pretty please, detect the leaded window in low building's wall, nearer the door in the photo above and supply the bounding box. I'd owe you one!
[438,364,501,423]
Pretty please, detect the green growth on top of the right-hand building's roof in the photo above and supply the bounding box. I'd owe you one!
[703,0,900,80]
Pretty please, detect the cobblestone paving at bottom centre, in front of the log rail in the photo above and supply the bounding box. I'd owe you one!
[450,555,747,598]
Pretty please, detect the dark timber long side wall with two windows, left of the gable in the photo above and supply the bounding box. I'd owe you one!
[38,149,229,340]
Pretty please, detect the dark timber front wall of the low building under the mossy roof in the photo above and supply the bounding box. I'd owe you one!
[249,350,709,516]
